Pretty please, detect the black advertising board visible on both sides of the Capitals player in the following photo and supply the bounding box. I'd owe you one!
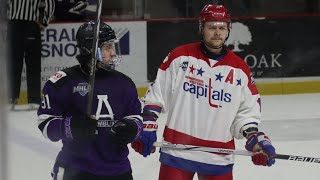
[147,17,320,81]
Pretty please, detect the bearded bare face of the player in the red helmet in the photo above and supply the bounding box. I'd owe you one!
[202,21,229,49]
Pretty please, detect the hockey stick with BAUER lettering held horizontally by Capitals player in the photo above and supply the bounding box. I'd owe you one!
[153,142,320,163]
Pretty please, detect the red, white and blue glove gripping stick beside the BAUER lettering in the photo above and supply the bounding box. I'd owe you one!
[246,132,277,166]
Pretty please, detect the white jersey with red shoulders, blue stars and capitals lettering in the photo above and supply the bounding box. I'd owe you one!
[143,42,260,174]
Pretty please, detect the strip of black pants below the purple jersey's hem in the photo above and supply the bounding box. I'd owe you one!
[51,167,133,180]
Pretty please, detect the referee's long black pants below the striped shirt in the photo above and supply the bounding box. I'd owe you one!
[8,20,41,103]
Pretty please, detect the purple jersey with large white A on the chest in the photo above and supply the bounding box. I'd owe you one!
[38,66,143,176]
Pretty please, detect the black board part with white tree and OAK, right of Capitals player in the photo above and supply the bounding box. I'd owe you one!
[226,17,320,78]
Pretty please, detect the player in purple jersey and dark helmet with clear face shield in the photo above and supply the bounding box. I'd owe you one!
[38,21,143,180]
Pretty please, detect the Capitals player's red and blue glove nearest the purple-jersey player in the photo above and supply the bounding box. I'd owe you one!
[131,110,158,157]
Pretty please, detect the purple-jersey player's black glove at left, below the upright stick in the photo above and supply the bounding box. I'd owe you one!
[62,115,97,141]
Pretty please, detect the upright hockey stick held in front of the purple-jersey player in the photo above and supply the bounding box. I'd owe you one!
[87,0,102,116]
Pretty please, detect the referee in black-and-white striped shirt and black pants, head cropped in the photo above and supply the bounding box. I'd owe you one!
[8,0,55,109]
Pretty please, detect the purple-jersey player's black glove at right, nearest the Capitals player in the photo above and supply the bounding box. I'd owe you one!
[109,118,142,145]
